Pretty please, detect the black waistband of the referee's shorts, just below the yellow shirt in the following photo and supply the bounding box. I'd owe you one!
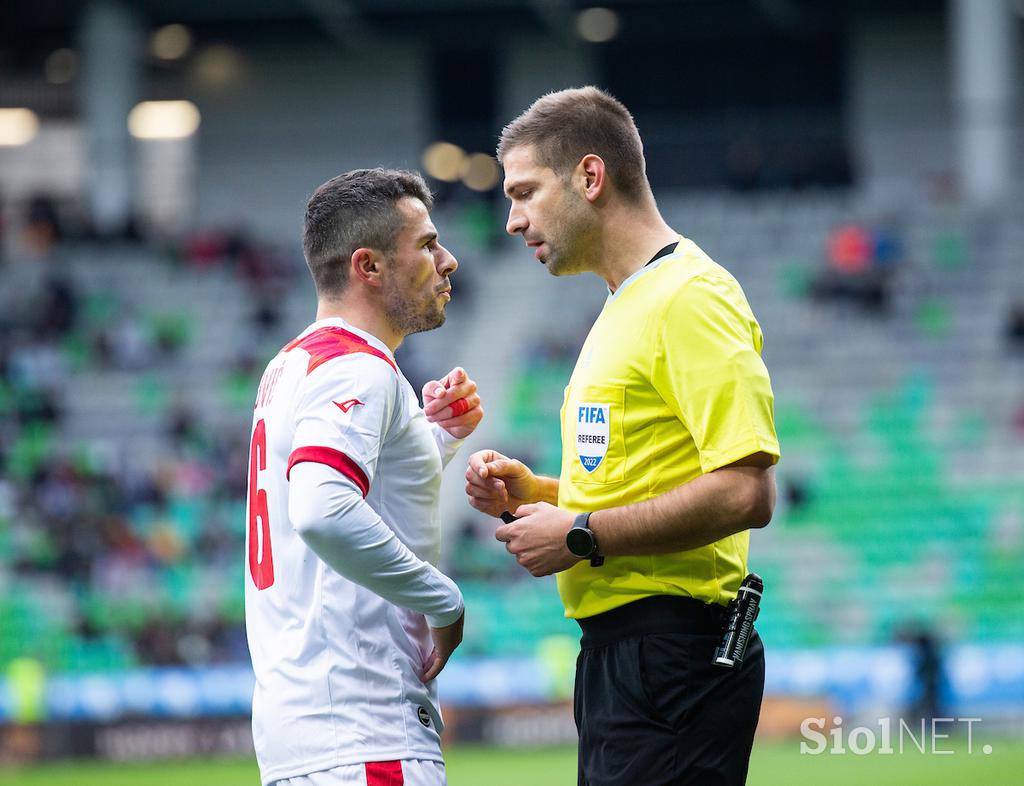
[577,595,725,649]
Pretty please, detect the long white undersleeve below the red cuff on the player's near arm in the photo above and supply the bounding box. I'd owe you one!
[288,462,463,627]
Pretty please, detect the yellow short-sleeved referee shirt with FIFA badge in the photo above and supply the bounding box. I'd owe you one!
[558,238,779,617]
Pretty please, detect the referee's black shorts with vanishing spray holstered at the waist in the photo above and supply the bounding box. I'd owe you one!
[573,596,765,786]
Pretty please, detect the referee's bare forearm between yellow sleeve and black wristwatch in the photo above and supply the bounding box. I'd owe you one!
[590,467,775,556]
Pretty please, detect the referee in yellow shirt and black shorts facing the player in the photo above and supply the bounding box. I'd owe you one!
[466,87,779,786]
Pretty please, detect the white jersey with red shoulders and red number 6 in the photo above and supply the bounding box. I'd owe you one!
[246,318,462,784]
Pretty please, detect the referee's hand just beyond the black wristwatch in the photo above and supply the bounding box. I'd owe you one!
[495,503,580,576]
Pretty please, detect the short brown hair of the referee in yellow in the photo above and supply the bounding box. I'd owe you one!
[498,86,650,202]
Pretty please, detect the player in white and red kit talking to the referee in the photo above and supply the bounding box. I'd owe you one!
[246,169,483,786]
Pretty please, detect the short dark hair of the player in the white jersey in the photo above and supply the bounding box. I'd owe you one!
[302,169,434,297]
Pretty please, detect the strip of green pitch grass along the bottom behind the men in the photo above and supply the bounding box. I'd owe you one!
[0,739,1024,786]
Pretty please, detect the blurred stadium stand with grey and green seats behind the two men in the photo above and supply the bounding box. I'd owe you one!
[0,187,1024,672]
